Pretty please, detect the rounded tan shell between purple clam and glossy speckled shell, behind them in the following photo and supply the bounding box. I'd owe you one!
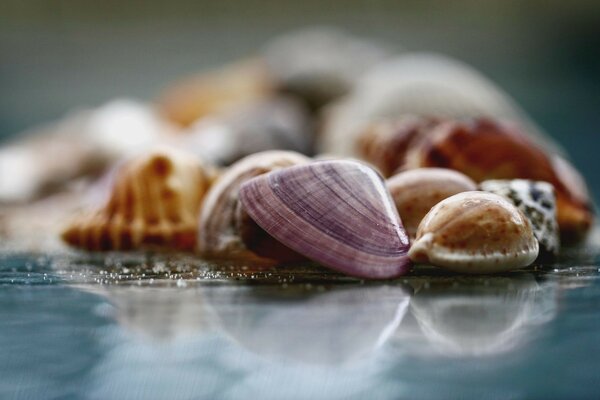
[386,168,477,239]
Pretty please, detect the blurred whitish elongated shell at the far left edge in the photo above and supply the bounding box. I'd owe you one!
[0,99,171,203]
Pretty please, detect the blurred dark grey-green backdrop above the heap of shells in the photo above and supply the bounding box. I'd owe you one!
[0,0,600,195]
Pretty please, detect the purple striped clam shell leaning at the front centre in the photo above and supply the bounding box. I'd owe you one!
[240,161,410,279]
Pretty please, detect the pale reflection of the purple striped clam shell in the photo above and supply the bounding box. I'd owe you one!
[207,285,410,365]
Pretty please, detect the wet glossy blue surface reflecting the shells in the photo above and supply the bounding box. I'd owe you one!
[0,236,600,399]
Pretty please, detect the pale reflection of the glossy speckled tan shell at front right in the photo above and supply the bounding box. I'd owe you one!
[410,275,556,357]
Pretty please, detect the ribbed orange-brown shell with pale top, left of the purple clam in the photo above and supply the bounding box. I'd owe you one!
[62,147,214,250]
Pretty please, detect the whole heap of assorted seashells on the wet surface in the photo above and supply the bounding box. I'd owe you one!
[0,29,594,279]
